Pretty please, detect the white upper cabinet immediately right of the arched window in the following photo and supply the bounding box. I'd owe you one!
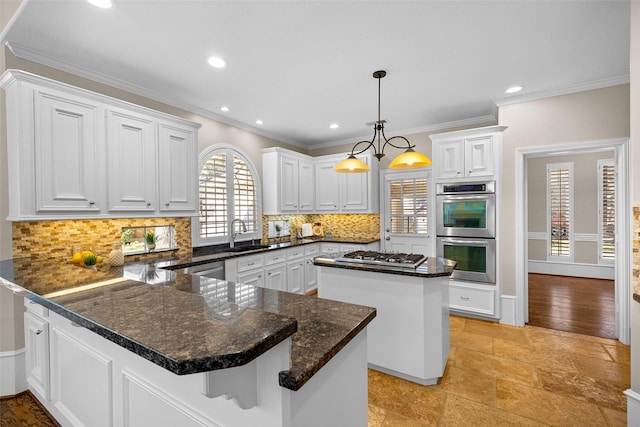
[262,148,315,215]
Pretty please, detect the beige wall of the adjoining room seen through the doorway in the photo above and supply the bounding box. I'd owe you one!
[527,151,614,264]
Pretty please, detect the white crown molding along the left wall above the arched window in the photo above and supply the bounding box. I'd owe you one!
[5,42,307,149]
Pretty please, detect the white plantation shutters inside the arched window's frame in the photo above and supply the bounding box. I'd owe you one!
[199,148,259,242]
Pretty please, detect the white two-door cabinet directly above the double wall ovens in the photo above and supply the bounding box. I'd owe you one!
[430,126,506,181]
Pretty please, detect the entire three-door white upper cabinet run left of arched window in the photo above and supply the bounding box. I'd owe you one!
[0,70,200,221]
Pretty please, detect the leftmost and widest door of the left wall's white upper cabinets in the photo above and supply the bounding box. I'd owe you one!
[34,91,104,213]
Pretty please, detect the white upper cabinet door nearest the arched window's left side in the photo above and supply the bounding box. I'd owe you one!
[158,123,198,212]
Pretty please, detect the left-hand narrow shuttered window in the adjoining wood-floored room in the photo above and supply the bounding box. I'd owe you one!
[547,163,573,261]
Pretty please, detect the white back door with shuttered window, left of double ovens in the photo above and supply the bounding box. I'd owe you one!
[380,168,435,256]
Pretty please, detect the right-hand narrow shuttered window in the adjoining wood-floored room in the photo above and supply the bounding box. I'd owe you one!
[598,159,616,264]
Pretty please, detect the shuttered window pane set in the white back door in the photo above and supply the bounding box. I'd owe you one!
[389,178,428,234]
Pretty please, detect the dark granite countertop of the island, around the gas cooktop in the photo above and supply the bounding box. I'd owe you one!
[313,254,457,278]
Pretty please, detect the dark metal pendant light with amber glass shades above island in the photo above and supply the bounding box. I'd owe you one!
[333,70,431,173]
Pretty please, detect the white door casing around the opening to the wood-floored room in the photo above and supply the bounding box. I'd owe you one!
[516,139,631,344]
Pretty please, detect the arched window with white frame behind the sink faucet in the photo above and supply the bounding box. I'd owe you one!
[192,145,262,246]
